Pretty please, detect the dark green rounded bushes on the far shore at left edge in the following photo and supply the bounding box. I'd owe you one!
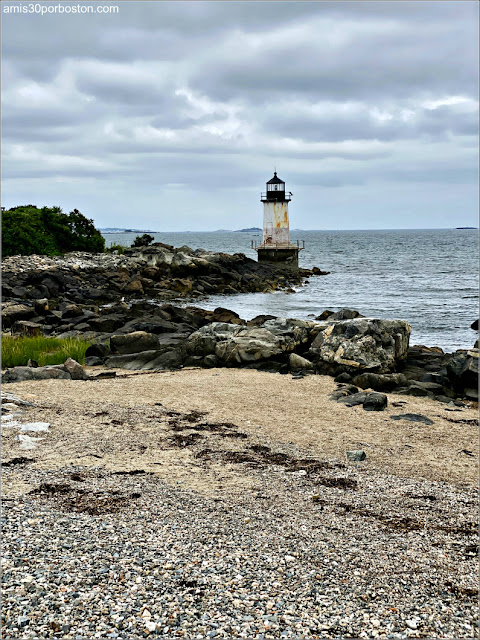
[2,204,105,256]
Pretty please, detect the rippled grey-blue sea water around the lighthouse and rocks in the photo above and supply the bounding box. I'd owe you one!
[105,229,478,352]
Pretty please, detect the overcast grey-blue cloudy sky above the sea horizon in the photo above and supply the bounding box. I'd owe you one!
[1,0,479,231]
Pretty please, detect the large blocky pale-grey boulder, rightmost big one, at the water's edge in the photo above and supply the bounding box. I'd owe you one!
[309,318,412,374]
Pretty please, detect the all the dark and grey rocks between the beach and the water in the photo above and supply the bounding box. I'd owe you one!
[2,243,478,403]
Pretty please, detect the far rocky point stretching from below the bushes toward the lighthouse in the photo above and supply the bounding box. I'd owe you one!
[2,243,327,312]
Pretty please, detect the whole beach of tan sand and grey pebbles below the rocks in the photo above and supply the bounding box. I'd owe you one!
[2,370,478,639]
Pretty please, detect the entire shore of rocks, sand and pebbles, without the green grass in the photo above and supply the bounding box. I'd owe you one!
[2,246,478,640]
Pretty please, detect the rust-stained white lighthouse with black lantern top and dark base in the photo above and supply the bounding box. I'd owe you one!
[252,171,303,268]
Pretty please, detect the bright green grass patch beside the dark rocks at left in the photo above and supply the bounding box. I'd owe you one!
[2,334,90,368]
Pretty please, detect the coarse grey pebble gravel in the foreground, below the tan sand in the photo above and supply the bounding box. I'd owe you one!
[2,378,478,639]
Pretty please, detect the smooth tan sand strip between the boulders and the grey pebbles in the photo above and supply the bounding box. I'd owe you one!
[2,369,478,494]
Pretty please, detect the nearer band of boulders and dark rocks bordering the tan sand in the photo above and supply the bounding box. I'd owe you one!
[3,301,478,407]
